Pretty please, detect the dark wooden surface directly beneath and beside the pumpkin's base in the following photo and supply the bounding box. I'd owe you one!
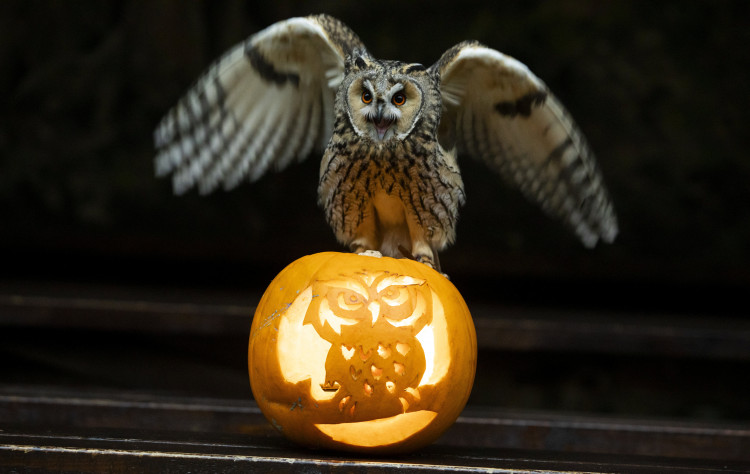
[0,387,750,472]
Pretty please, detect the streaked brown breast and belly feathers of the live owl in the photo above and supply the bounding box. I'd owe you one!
[318,121,464,256]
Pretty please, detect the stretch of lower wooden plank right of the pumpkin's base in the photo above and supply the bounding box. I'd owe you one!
[446,407,750,461]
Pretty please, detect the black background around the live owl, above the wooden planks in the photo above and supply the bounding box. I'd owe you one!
[0,0,750,424]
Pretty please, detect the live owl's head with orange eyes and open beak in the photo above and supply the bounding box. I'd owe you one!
[339,56,439,143]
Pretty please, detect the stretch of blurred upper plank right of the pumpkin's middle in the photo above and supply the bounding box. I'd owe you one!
[471,305,750,360]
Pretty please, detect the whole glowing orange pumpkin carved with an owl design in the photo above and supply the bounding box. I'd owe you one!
[248,252,477,453]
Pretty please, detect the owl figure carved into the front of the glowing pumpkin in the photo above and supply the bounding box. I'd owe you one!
[303,272,432,421]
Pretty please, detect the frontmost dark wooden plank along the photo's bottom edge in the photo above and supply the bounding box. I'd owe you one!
[0,430,750,473]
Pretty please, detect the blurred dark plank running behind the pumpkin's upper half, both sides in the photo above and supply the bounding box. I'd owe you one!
[0,285,750,360]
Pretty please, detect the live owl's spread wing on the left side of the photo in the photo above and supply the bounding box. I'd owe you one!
[154,15,367,194]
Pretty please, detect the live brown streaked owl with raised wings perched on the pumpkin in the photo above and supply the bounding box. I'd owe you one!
[155,15,618,269]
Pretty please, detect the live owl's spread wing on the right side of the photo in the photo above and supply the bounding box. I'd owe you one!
[432,42,618,247]
